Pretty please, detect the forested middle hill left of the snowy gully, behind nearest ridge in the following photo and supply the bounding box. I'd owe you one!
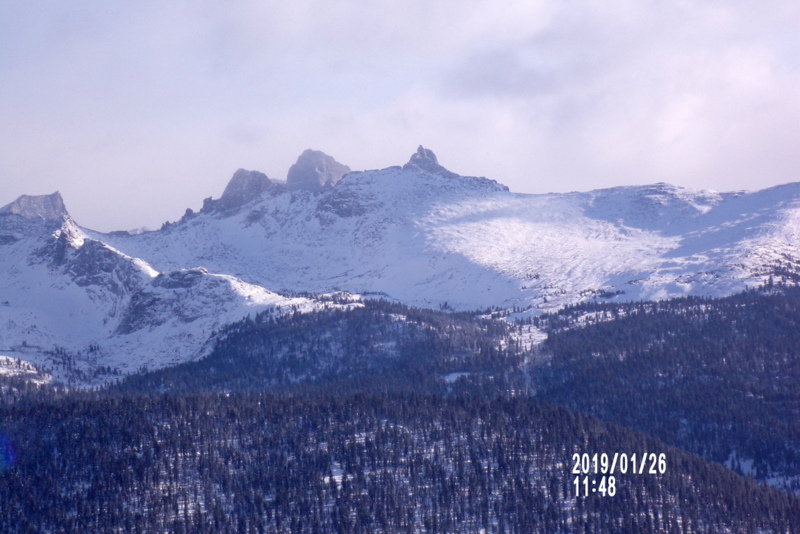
[120,301,524,395]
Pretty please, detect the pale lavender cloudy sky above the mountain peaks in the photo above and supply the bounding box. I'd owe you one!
[0,0,800,230]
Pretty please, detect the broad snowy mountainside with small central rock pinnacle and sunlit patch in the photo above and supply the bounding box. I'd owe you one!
[97,147,800,310]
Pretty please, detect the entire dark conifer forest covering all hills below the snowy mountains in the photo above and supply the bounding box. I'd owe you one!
[0,287,800,533]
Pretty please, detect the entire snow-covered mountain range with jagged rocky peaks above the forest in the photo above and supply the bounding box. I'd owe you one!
[0,147,800,386]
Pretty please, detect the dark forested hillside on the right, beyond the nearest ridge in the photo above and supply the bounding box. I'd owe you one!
[535,287,800,491]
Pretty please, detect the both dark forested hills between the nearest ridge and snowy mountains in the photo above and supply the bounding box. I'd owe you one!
[120,287,800,491]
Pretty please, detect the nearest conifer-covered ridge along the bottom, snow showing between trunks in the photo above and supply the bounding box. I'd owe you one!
[0,393,800,533]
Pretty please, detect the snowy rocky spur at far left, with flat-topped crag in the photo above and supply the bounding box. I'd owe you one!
[0,194,328,385]
